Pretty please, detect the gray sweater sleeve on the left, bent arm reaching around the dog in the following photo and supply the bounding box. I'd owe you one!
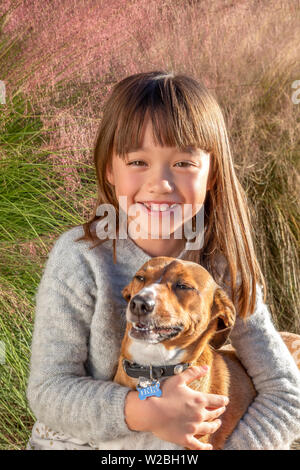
[26,232,136,443]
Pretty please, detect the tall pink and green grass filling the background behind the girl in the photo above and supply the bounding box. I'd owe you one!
[0,0,300,449]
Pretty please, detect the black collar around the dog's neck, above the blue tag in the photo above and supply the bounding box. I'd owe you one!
[123,359,191,379]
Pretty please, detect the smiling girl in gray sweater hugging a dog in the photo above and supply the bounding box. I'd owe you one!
[27,72,300,450]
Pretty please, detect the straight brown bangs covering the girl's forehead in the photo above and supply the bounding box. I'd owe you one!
[114,75,214,159]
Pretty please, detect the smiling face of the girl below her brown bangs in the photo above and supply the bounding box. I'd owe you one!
[106,120,210,256]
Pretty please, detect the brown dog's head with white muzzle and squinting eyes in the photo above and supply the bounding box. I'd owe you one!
[122,256,236,349]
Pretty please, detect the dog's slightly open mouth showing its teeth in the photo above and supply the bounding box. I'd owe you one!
[129,322,183,342]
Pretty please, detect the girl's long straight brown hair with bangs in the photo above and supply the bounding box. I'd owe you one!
[76,71,266,318]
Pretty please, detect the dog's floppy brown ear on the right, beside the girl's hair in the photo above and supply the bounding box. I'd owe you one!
[210,288,236,349]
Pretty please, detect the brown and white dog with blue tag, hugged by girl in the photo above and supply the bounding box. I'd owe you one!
[99,256,300,450]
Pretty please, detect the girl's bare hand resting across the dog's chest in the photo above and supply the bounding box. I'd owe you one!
[147,366,228,450]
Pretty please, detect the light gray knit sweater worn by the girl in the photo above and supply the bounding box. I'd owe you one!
[27,226,300,450]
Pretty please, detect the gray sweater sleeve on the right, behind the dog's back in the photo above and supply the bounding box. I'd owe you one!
[224,284,300,450]
